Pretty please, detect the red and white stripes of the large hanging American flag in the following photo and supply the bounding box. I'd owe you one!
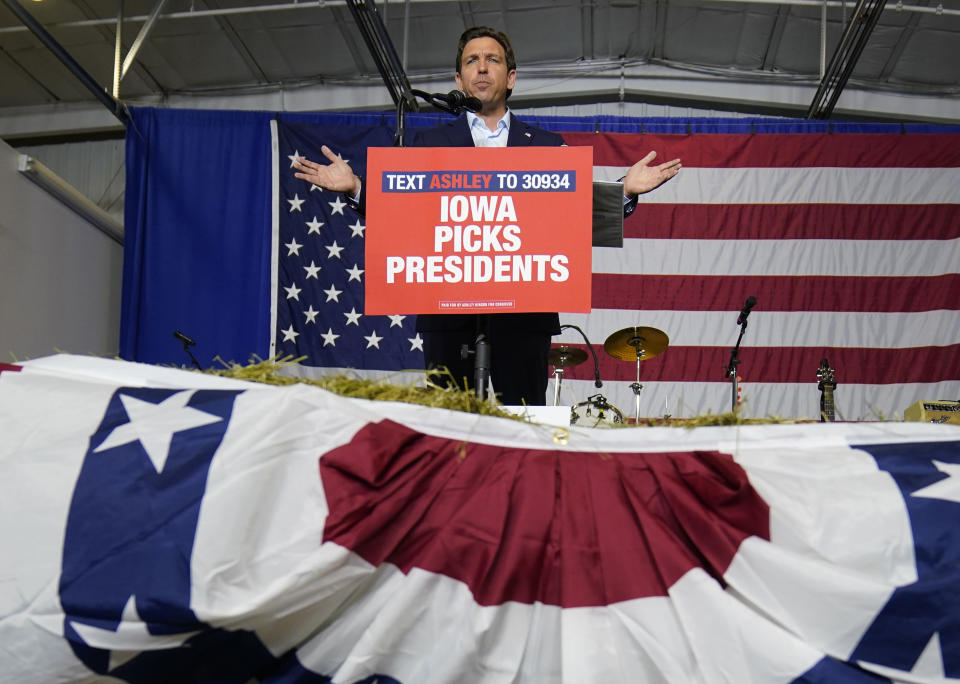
[550,133,960,420]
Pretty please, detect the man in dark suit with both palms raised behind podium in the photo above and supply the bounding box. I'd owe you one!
[296,26,680,405]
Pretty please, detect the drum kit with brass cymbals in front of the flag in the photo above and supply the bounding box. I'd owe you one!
[549,325,670,427]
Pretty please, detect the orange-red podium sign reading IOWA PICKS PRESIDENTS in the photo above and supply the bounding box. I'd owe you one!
[364,147,593,315]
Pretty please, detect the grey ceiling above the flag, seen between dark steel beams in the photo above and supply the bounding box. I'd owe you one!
[0,0,960,134]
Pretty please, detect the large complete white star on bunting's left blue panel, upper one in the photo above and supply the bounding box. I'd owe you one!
[93,390,223,473]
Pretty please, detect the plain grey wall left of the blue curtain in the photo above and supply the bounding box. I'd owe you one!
[0,141,123,362]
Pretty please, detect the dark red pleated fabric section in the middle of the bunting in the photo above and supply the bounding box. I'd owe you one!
[320,420,770,608]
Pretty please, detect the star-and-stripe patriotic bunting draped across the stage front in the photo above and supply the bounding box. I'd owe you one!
[0,355,960,684]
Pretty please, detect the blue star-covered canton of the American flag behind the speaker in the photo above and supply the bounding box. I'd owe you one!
[271,122,423,370]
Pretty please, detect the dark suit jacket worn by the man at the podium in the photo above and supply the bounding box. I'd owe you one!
[413,114,564,335]
